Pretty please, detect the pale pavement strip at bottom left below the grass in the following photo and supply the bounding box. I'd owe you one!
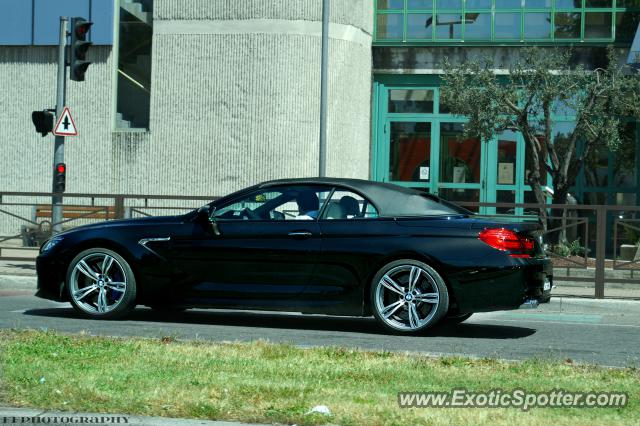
[0,407,264,426]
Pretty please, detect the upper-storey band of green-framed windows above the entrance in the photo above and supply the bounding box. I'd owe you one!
[374,0,640,46]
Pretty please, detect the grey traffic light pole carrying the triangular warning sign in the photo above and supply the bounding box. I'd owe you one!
[51,16,68,234]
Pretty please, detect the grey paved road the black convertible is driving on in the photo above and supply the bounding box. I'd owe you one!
[0,276,640,367]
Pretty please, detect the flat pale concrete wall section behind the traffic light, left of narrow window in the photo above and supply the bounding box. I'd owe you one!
[0,46,113,193]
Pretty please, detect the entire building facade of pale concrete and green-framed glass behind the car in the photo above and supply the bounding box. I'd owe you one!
[0,0,640,231]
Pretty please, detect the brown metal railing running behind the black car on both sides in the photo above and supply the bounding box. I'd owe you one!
[0,192,640,298]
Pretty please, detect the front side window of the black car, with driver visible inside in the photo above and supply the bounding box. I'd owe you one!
[214,185,330,220]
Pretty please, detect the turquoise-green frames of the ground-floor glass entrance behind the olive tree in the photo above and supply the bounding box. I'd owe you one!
[371,75,640,215]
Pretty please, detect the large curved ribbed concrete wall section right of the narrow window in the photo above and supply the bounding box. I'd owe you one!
[113,0,373,195]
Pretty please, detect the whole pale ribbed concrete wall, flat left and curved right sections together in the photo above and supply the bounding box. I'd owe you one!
[0,0,373,236]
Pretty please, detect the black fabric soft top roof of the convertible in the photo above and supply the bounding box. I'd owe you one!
[257,178,470,217]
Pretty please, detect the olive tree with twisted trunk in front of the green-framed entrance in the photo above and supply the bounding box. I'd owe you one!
[442,48,640,233]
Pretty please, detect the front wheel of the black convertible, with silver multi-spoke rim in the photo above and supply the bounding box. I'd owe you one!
[67,248,136,319]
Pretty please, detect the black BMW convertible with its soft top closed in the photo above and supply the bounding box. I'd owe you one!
[37,178,552,333]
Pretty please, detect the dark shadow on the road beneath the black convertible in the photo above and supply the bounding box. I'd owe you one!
[24,308,536,339]
